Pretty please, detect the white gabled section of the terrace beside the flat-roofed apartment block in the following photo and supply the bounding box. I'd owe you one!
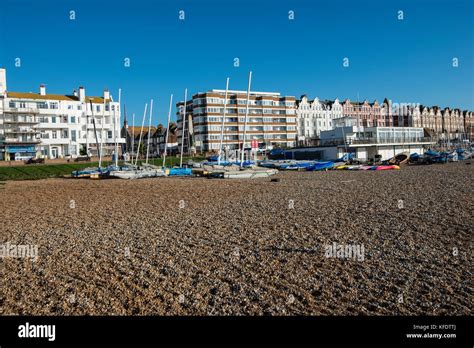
[296,95,343,145]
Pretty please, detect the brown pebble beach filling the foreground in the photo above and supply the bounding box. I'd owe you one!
[0,163,474,315]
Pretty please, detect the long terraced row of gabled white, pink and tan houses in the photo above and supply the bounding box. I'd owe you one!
[296,95,474,145]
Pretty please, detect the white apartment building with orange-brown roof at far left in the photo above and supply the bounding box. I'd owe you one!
[0,69,125,160]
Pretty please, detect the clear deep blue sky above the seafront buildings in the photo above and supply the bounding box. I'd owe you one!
[0,0,474,124]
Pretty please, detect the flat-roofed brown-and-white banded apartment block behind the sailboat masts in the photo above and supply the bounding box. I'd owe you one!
[176,89,296,153]
